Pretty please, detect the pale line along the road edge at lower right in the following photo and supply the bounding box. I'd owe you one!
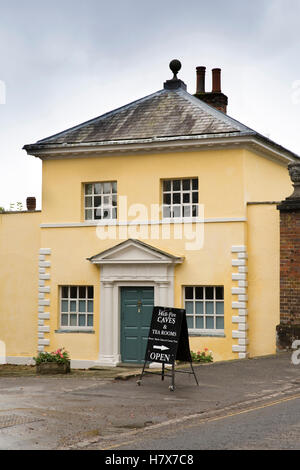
[101,394,300,450]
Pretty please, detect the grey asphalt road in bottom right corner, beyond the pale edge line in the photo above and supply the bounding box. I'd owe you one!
[107,395,300,451]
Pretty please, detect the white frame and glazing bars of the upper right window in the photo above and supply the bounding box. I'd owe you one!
[162,177,199,221]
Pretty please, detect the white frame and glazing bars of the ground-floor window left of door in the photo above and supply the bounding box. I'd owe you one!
[59,284,95,331]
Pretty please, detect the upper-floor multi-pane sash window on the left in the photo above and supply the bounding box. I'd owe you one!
[84,181,117,220]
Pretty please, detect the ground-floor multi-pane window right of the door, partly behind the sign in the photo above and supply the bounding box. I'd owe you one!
[184,286,224,331]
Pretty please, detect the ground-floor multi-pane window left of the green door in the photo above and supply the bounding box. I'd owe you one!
[60,286,94,329]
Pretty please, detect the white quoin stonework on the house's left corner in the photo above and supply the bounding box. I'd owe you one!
[37,248,51,352]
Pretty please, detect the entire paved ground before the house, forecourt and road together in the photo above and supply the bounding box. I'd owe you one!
[0,353,300,450]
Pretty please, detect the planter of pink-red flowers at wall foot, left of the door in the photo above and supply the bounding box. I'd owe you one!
[33,348,71,374]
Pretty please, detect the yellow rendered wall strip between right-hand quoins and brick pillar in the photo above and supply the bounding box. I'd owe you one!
[248,204,280,357]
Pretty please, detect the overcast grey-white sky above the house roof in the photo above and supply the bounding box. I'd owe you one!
[0,0,300,208]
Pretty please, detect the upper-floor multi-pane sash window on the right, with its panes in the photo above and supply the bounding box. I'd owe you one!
[163,178,199,219]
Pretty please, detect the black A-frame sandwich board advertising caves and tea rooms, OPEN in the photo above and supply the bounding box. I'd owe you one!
[137,307,198,391]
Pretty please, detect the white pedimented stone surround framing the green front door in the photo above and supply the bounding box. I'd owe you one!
[89,239,183,367]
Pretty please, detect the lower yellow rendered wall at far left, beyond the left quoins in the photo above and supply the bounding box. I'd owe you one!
[0,212,41,361]
